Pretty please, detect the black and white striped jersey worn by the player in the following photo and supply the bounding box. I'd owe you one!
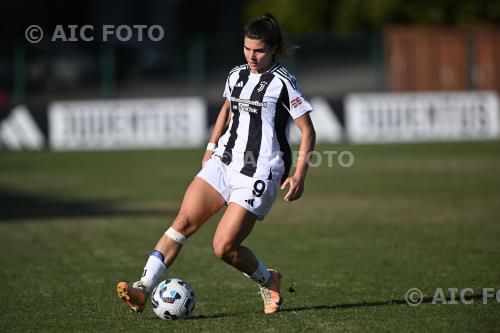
[214,63,312,182]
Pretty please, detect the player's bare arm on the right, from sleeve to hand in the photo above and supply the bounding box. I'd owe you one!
[281,112,316,201]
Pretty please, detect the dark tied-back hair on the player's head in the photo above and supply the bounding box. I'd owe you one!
[244,13,286,60]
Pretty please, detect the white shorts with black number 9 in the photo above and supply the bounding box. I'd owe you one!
[196,156,281,220]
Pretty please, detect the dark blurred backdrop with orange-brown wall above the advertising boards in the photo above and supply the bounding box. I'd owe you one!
[0,0,500,146]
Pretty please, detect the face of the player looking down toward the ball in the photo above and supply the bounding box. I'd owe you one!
[243,37,276,74]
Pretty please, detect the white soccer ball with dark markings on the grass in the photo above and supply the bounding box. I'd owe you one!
[151,279,196,320]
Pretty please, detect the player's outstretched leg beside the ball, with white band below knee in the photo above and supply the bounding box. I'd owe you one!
[116,177,225,312]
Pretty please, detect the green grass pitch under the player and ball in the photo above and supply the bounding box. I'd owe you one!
[0,142,500,332]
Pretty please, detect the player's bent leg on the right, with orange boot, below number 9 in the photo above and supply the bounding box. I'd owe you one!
[213,202,282,313]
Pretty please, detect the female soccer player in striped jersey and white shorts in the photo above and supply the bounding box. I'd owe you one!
[117,14,315,313]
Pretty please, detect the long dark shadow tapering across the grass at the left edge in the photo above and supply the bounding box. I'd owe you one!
[0,187,177,223]
